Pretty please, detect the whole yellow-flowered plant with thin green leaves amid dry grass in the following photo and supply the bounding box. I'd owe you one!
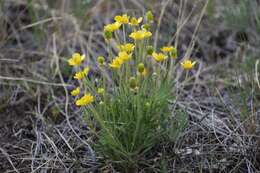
[68,11,195,172]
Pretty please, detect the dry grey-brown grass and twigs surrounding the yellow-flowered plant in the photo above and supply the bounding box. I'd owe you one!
[0,0,260,173]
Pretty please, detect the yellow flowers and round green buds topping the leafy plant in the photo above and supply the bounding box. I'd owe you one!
[68,11,196,106]
